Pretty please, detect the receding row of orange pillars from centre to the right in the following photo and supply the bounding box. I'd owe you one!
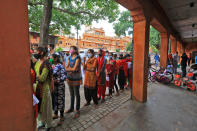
[132,18,184,102]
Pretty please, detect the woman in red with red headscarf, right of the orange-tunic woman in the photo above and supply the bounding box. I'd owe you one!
[97,49,107,103]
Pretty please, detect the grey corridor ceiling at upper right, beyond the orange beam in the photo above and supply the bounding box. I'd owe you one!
[158,0,197,42]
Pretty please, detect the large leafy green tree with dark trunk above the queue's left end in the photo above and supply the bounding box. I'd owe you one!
[28,0,119,44]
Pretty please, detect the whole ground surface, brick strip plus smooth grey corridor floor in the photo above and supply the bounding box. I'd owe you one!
[38,83,197,131]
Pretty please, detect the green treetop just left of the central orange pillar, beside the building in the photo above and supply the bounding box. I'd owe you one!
[113,11,133,37]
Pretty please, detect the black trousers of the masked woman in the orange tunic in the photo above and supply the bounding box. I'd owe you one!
[84,87,98,105]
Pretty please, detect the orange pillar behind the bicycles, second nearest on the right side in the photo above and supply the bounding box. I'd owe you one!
[160,33,169,67]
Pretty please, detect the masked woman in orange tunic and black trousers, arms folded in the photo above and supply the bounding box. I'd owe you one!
[84,49,98,106]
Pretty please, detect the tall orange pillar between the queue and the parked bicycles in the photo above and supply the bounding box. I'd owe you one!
[132,19,150,102]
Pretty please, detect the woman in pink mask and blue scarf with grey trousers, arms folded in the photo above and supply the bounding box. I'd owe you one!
[66,46,82,118]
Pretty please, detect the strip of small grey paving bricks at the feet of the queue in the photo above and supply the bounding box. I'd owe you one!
[39,85,130,131]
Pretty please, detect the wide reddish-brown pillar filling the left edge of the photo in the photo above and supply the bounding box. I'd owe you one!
[0,0,33,131]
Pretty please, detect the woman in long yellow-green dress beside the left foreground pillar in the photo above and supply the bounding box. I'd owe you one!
[35,47,53,129]
